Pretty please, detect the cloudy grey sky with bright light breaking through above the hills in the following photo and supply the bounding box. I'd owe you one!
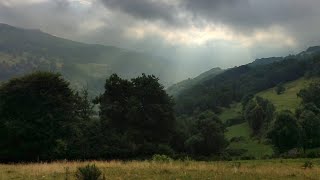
[0,0,320,77]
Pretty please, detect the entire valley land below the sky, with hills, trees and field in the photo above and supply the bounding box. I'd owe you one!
[0,24,320,179]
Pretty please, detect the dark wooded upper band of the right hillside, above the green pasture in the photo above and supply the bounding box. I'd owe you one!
[175,55,320,115]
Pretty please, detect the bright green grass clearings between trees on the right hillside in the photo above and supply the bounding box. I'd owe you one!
[220,78,313,158]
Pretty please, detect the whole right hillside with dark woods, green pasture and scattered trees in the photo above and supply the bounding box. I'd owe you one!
[169,47,320,159]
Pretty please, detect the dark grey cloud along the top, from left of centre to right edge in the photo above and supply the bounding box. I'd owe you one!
[101,0,320,33]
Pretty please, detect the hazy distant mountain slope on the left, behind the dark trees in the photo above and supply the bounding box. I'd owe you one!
[0,24,175,91]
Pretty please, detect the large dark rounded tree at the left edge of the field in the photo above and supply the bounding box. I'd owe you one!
[0,72,77,161]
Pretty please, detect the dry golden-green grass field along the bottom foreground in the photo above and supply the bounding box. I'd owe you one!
[0,159,320,180]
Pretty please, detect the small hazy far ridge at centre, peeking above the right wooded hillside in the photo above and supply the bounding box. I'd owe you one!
[167,68,223,97]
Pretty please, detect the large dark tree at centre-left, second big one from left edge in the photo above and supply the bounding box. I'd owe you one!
[96,74,175,157]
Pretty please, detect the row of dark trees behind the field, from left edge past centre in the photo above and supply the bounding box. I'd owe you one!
[0,72,228,162]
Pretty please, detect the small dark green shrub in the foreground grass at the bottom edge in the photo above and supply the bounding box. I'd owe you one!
[75,164,104,180]
